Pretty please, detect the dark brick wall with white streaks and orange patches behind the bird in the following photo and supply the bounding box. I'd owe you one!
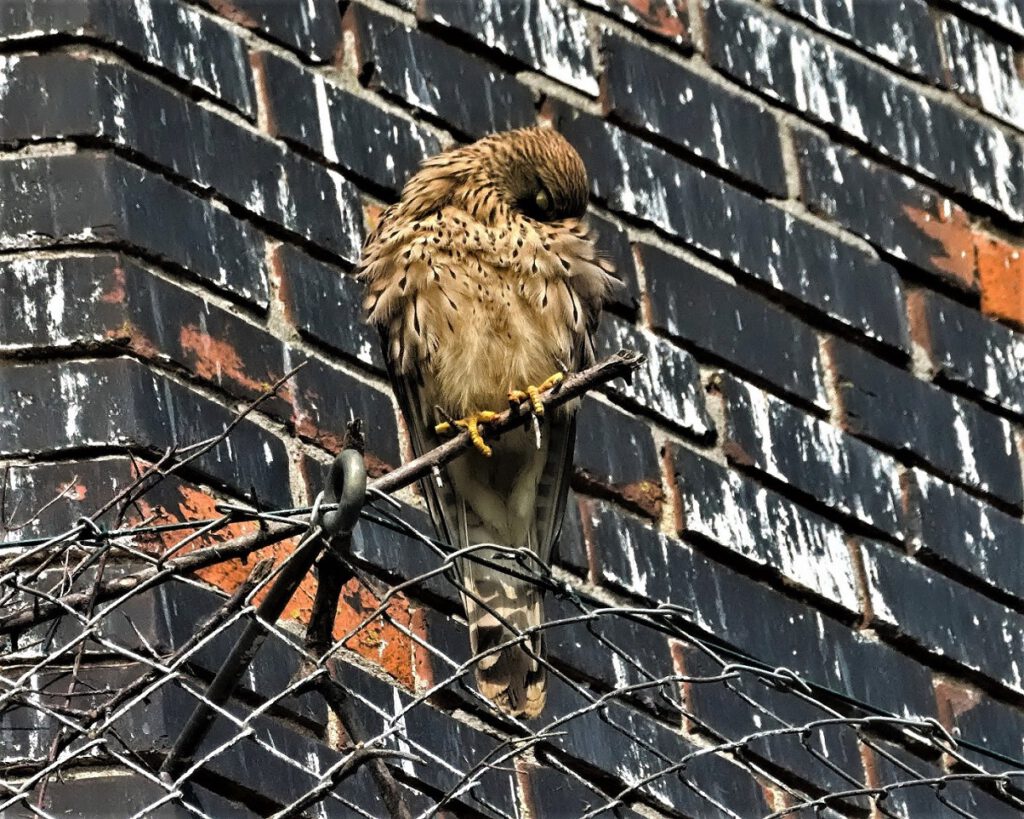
[0,0,1024,817]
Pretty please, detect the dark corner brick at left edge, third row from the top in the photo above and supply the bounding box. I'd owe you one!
[0,152,267,307]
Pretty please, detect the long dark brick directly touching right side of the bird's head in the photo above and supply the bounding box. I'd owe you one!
[554,107,909,351]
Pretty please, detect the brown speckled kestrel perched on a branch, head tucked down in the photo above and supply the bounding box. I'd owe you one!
[357,128,617,718]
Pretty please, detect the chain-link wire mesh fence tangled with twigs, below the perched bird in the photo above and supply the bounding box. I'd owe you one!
[0,362,1024,819]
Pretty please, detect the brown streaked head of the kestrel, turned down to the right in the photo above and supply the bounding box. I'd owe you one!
[402,128,587,222]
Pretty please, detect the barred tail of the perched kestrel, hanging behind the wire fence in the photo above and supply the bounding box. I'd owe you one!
[463,549,548,719]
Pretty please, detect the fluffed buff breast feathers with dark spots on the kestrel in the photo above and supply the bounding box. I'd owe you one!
[364,208,610,416]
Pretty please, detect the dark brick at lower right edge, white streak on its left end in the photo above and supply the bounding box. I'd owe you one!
[861,543,1024,692]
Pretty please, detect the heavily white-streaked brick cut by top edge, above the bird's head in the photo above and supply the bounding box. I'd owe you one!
[417,0,597,95]
